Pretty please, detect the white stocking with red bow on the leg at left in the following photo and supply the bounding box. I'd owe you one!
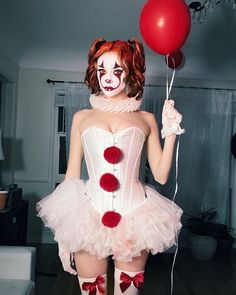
[78,274,107,295]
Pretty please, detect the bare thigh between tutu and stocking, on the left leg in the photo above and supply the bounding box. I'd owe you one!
[74,251,107,278]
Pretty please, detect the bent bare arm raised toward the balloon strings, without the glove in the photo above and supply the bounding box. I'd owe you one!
[147,113,176,184]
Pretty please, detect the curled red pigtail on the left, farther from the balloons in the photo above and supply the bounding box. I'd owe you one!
[84,38,106,94]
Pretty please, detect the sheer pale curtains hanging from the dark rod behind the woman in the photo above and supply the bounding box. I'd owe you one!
[63,84,236,223]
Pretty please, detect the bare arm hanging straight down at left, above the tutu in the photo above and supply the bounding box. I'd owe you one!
[65,111,84,179]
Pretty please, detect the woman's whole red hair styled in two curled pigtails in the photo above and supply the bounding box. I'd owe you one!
[84,38,146,99]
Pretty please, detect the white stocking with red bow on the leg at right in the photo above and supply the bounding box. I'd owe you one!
[114,268,144,295]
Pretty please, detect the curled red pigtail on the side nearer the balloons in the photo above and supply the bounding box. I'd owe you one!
[128,38,146,99]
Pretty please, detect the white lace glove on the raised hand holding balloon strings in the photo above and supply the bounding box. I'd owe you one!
[161,100,185,138]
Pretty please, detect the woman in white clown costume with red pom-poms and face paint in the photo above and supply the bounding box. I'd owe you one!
[37,39,184,295]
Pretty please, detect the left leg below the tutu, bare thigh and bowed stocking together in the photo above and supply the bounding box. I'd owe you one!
[74,251,107,295]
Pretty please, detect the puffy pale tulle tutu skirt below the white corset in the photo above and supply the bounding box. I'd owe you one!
[37,179,183,262]
